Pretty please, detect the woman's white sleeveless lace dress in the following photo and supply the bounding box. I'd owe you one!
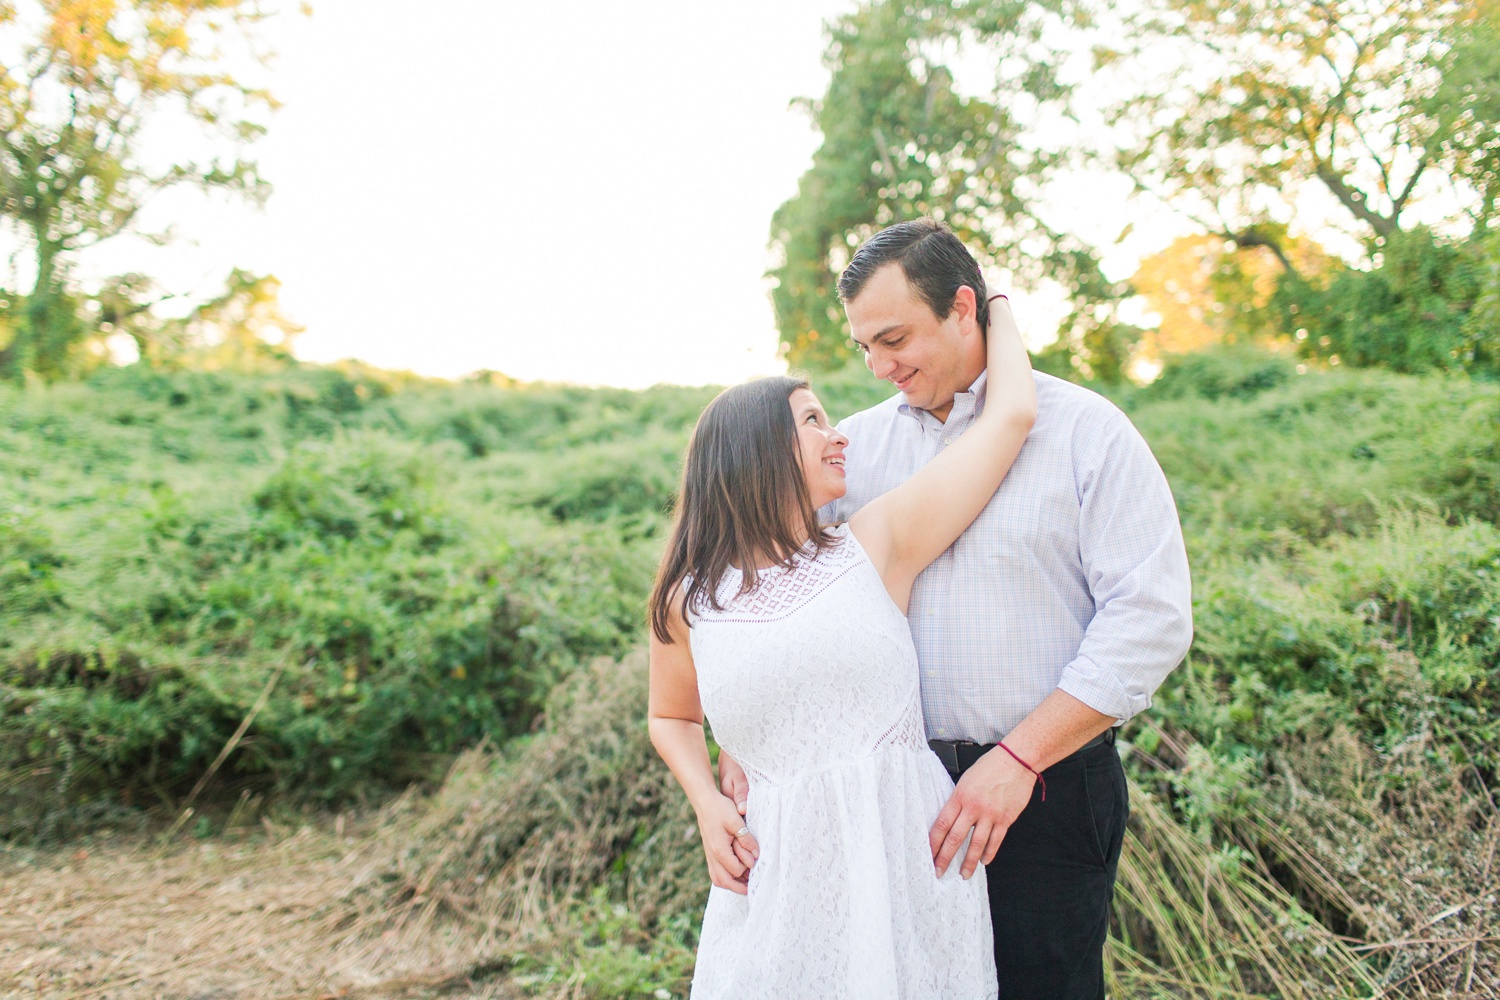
[690,528,996,1000]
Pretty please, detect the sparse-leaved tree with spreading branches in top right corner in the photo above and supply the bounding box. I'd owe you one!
[1116,0,1500,271]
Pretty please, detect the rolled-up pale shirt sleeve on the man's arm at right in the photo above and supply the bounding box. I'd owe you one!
[1058,411,1193,721]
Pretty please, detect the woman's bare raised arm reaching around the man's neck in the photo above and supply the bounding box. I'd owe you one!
[849,298,1037,612]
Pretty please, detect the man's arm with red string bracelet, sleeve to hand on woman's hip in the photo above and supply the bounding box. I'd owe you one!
[929,414,1193,877]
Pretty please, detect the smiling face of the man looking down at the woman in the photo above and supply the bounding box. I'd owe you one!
[845,262,984,420]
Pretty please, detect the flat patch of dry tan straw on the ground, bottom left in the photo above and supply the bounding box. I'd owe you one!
[0,820,486,1000]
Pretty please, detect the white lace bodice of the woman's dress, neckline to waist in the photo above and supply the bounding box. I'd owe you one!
[690,525,927,783]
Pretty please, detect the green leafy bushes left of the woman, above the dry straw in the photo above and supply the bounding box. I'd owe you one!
[0,369,690,835]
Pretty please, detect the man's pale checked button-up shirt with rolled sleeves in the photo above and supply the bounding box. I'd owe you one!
[822,372,1193,744]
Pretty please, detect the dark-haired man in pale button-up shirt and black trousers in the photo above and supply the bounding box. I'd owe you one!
[720,219,1193,1000]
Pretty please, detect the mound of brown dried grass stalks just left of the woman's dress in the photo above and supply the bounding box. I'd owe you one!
[371,654,708,964]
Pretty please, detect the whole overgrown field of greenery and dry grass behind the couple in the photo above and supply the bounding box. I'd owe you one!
[0,354,1500,999]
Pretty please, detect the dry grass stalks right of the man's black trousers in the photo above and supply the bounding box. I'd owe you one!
[1113,716,1500,999]
